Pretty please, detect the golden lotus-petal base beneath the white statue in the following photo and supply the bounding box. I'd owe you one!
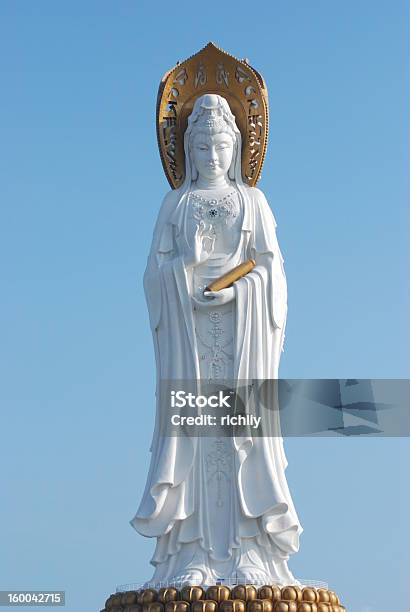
[101,584,346,612]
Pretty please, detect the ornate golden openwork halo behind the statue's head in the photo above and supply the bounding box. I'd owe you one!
[157,42,268,189]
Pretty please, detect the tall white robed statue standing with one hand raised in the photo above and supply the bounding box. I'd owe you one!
[131,94,302,585]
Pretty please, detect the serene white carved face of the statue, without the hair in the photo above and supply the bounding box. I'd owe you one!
[191,132,233,180]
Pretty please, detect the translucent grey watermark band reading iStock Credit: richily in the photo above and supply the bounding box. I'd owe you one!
[157,378,410,437]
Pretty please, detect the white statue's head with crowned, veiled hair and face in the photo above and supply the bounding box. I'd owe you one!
[184,94,242,181]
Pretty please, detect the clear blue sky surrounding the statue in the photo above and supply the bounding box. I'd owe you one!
[0,0,410,612]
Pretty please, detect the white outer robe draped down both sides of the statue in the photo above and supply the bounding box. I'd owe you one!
[131,187,302,574]
